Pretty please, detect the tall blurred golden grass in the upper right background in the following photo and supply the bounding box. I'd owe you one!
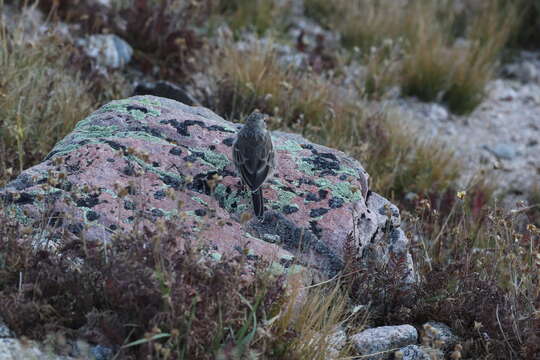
[306,0,519,114]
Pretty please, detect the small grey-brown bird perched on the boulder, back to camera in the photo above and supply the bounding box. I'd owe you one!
[233,110,276,218]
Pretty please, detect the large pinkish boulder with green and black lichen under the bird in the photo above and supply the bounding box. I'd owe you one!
[0,96,412,275]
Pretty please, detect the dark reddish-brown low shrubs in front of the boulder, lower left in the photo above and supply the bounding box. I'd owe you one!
[0,217,282,359]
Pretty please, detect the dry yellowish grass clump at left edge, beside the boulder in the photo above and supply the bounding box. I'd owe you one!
[0,28,95,185]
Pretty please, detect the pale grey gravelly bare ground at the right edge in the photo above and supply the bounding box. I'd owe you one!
[391,56,540,206]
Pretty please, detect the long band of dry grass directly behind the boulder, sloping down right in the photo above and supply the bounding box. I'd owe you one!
[211,40,459,199]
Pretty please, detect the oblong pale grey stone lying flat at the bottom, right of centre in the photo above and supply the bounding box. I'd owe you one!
[351,325,418,360]
